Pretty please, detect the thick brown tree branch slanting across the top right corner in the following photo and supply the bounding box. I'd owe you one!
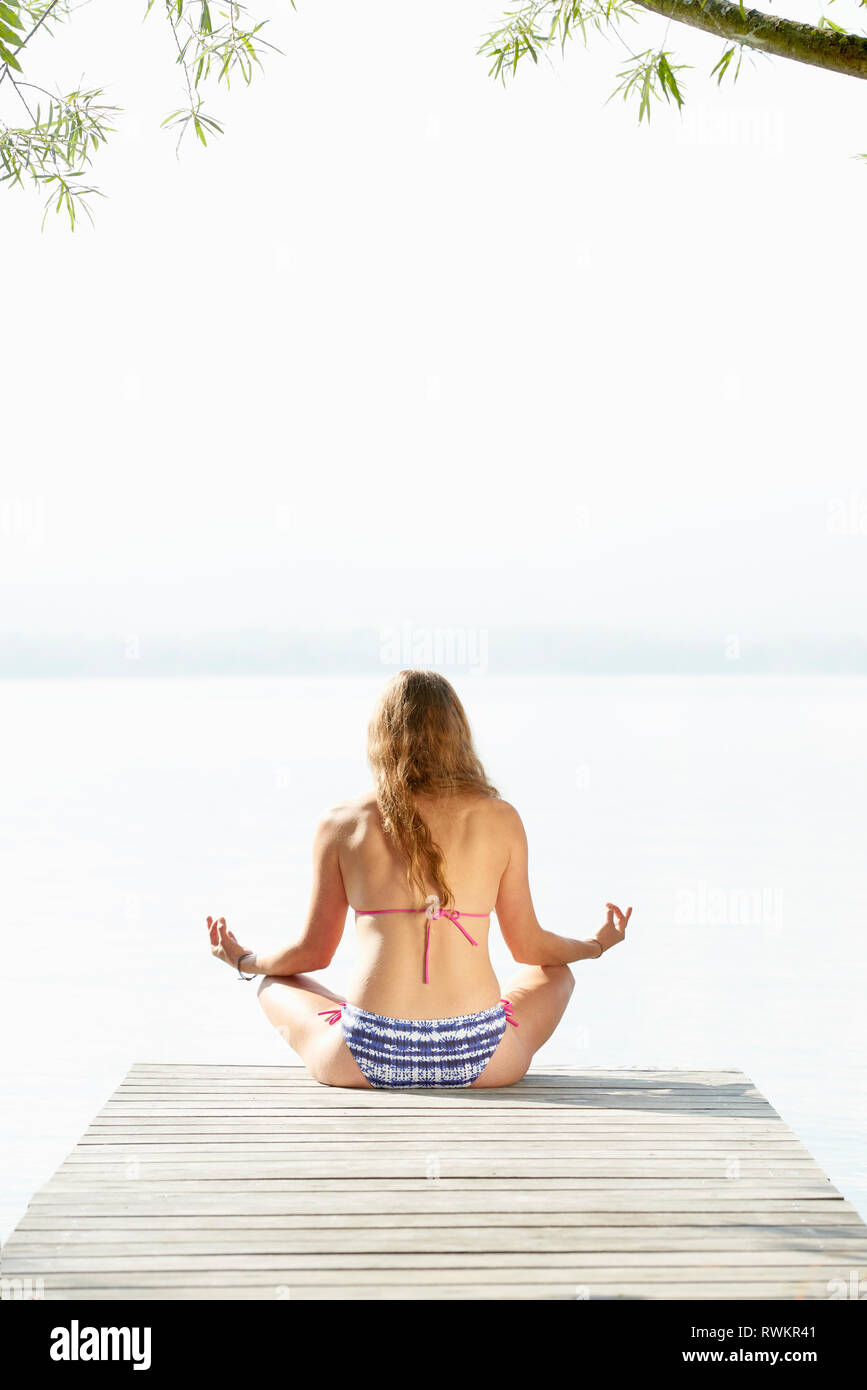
[635,0,867,78]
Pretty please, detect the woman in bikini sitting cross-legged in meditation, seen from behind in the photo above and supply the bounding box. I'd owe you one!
[207,671,632,1087]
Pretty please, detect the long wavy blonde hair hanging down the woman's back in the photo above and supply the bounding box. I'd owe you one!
[367,670,499,908]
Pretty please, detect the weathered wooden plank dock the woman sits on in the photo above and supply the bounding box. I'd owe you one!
[3,1063,867,1300]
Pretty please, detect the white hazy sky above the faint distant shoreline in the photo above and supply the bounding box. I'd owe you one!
[0,0,867,650]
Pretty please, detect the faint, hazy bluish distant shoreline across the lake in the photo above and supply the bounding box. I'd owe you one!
[0,621,867,680]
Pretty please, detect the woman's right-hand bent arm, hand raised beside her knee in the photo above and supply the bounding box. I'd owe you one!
[496,802,632,965]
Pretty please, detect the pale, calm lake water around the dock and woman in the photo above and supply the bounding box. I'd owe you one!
[0,671,867,1236]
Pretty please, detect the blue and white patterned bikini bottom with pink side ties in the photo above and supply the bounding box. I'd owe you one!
[333,999,517,1087]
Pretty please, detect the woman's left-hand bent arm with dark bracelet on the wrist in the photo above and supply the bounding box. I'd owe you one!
[207,810,349,976]
